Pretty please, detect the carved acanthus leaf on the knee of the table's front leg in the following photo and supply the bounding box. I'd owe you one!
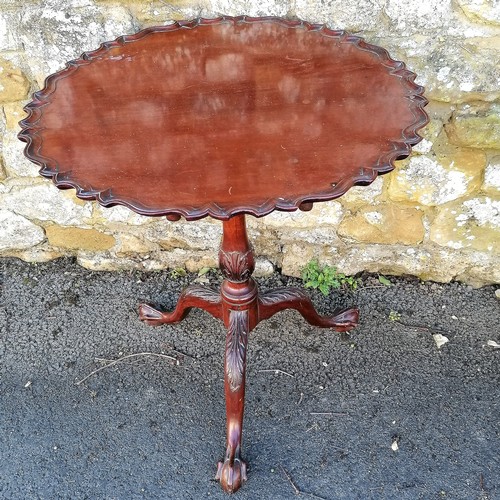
[226,311,248,392]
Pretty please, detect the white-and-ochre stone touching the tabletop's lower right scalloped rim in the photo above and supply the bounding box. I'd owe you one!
[388,148,486,206]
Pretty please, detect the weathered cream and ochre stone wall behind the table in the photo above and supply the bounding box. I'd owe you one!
[0,0,500,285]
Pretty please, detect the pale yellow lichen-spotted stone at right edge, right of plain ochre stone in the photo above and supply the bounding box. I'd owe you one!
[430,196,500,250]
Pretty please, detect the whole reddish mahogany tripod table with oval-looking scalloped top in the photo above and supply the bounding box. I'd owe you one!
[19,16,427,492]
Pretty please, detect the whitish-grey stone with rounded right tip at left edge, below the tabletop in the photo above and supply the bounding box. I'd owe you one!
[0,209,45,250]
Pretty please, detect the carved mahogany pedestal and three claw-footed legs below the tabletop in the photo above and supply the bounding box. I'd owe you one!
[139,215,359,493]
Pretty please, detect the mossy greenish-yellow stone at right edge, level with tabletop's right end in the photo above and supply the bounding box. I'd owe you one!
[445,101,500,149]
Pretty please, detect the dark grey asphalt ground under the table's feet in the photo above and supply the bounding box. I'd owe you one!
[0,258,500,500]
